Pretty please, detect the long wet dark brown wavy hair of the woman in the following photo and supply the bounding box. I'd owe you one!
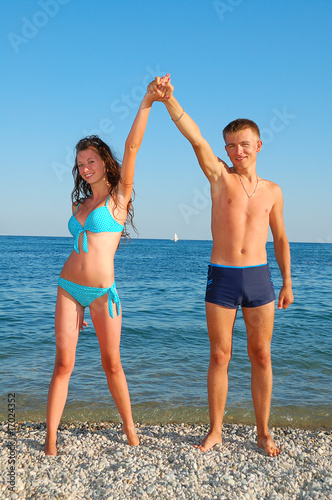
[71,135,137,239]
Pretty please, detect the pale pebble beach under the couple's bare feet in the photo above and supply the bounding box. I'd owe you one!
[0,422,332,500]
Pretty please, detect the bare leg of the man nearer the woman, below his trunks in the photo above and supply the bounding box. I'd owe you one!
[197,302,237,451]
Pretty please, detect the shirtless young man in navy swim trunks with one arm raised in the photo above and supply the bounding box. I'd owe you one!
[148,77,294,456]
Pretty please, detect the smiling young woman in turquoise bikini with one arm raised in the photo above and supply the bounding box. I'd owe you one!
[44,83,167,455]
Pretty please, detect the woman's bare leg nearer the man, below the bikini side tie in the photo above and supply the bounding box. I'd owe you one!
[90,294,139,445]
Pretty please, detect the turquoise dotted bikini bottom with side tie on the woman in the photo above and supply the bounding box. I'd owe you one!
[58,277,120,318]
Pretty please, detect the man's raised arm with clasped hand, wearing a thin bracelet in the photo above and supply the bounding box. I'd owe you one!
[148,75,224,180]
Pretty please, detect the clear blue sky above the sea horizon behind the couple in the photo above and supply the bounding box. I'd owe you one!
[0,0,332,242]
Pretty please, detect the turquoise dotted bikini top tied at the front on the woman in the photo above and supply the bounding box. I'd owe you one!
[68,193,123,253]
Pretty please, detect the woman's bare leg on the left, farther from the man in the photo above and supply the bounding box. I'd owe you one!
[44,287,84,455]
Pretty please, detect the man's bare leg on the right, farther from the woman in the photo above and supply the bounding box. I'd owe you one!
[242,301,280,456]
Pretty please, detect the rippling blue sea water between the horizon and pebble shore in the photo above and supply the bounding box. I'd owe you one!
[0,236,332,427]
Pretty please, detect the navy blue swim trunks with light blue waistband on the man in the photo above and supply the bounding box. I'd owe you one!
[205,264,276,309]
